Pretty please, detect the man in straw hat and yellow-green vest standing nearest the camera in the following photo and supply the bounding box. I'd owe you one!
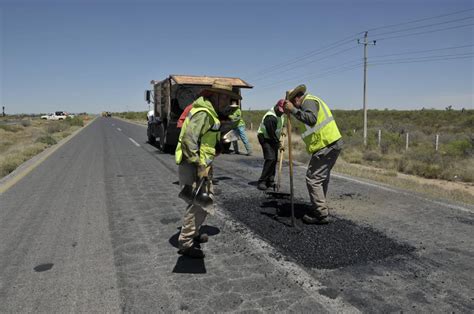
[175,79,240,258]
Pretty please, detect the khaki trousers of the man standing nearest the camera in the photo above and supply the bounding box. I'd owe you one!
[178,162,213,249]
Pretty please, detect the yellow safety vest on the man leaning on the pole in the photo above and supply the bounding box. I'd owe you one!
[301,94,342,154]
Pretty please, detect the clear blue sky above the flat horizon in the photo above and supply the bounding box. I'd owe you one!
[0,0,474,113]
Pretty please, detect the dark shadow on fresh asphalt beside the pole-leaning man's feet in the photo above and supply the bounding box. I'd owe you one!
[260,200,311,226]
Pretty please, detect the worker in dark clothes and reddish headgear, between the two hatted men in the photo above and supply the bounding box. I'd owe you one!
[257,99,285,191]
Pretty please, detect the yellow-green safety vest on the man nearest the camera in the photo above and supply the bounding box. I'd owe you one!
[175,98,221,167]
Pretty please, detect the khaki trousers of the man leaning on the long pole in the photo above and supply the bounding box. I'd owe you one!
[306,148,341,218]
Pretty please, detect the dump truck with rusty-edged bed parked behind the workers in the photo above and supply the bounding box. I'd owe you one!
[145,75,253,153]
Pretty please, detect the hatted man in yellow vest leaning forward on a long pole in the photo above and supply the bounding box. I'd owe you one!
[285,85,342,224]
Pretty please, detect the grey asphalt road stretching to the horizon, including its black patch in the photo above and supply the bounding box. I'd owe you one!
[0,118,474,313]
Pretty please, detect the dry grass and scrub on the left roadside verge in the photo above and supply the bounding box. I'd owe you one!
[0,119,85,178]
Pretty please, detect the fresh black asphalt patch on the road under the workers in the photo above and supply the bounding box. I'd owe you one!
[220,192,414,269]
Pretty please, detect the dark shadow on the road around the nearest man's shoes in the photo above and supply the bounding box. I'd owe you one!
[169,225,220,274]
